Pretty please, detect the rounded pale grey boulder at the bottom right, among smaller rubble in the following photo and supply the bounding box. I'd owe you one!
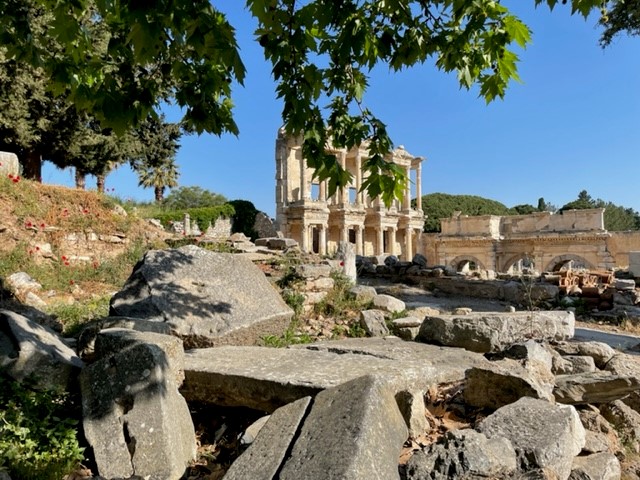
[477,397,585,480]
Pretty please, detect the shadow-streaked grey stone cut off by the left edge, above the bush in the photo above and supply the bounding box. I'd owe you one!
[0,310,84,390]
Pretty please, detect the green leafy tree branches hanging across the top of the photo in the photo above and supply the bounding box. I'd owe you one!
[0,0,631,203]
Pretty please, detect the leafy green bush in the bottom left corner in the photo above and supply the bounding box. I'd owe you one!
[0,375,84,480]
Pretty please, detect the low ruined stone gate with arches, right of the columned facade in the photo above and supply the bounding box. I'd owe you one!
[423,208,640,272]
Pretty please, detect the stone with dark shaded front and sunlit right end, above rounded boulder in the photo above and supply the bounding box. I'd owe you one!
[463,359,553,410]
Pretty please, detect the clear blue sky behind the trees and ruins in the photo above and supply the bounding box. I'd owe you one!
[43,0,640,216]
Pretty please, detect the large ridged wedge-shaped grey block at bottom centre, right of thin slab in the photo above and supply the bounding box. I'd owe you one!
[278,376,407,480]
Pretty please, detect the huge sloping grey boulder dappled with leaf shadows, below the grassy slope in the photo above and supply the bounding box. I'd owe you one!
[111,245,293,347]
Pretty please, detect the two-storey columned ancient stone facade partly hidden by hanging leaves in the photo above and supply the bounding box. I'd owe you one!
[276,130,424,260]
